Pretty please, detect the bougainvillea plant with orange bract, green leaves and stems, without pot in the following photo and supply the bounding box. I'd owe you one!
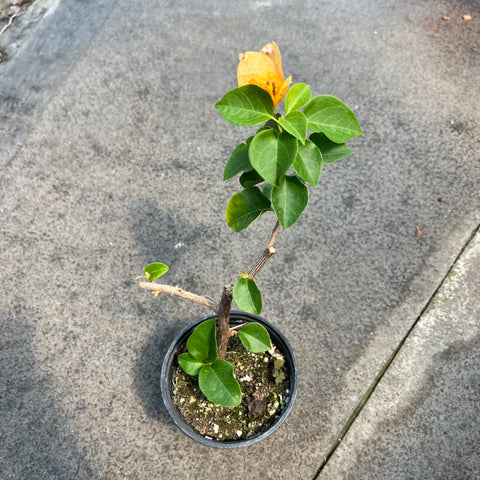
[140,42,362,407]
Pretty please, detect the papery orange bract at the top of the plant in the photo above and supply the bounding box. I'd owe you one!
[237,42,292,109]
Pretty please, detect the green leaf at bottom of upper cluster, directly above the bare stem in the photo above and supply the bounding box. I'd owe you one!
[272,175,308,228]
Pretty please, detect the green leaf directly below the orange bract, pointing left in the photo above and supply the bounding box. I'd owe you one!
[215,85,273,126]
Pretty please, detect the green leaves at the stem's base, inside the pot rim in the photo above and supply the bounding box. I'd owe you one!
[178,318,272,407]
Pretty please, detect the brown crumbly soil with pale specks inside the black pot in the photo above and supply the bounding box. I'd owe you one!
[173,336,290,441]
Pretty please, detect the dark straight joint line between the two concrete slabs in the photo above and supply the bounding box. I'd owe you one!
[312,224,480,480]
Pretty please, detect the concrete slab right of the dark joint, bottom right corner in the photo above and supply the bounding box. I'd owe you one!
[319,232,480,480]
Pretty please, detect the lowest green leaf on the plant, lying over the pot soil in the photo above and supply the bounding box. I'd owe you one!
[198,360,242,407]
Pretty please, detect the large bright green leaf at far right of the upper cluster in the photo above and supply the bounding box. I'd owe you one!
[303,95,363,143]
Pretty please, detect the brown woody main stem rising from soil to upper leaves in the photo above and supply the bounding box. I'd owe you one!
[217,220,280,360]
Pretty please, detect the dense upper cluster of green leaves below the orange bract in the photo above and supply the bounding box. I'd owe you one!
[215,83,363,232]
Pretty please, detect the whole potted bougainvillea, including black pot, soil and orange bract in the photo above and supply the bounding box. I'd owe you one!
[140,43,362,448]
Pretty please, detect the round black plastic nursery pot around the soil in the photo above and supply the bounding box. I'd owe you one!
[160,311,298,449]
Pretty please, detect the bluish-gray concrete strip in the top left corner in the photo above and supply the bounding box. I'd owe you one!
[0,0,113,167]
